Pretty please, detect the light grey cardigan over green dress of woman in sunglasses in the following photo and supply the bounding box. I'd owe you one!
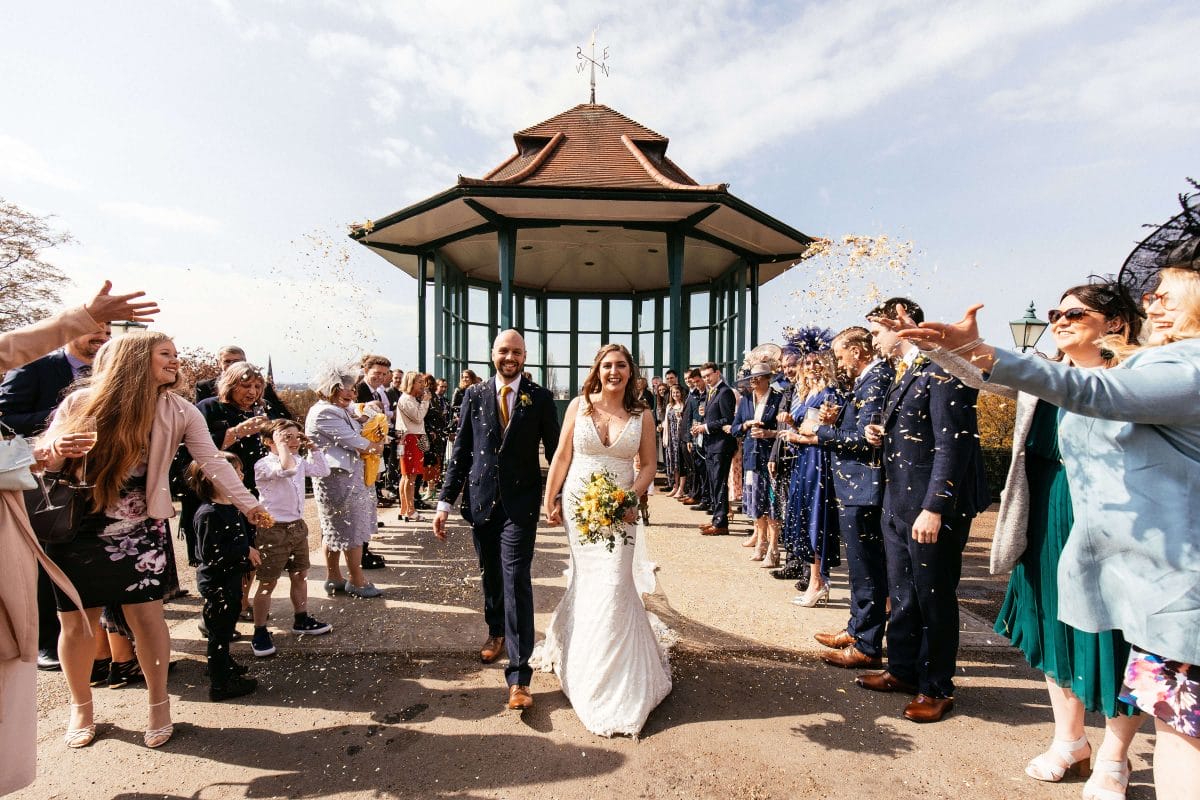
[926,348,1038,575]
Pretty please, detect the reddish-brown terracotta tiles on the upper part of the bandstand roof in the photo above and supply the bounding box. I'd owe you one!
[458,103,726,191]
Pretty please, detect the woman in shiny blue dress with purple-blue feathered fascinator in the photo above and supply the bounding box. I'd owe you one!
[782,351,842,608]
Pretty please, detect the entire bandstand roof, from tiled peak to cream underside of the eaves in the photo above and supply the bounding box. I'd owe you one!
[352,103,812,293]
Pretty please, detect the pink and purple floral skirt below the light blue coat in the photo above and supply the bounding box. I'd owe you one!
[1121,648,1200,738]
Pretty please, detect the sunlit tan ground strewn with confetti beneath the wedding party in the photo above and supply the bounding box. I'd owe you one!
[12,498,1153,800]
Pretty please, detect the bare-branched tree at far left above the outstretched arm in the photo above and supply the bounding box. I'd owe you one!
[0,198,73,331]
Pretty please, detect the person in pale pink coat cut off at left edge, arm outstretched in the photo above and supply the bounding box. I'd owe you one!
[0,281,158,794]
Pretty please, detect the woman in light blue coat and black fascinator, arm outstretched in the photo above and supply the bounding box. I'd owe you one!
[900,187,1200,800]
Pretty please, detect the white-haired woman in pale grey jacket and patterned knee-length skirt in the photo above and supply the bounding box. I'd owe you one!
[305,367,384,597]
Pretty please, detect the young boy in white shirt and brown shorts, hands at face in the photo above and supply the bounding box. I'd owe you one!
[251,420,334,658]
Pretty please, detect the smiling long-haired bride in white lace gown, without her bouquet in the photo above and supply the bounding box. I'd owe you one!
[530,344,671,736]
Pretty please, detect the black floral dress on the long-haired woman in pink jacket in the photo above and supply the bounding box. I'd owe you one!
[48,464,169,610]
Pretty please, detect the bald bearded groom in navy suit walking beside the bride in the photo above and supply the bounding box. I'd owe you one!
[433,330,558,710]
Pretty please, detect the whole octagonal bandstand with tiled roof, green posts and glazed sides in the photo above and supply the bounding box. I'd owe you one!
[350,103,811,399]
